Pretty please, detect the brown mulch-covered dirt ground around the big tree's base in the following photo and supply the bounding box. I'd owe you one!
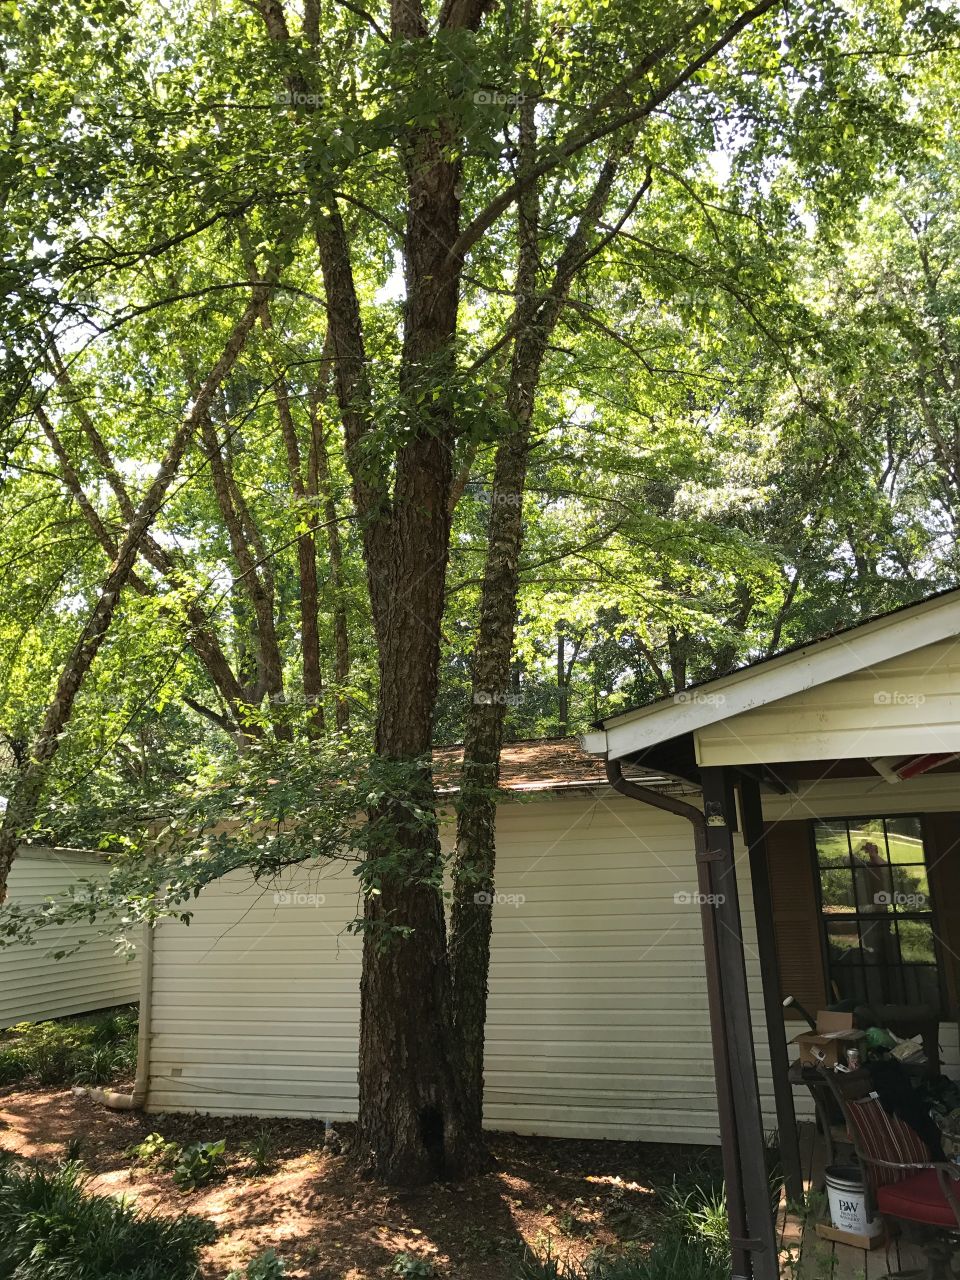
[0,1088,709,1280]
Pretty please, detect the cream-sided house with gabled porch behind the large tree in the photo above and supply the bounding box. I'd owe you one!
[133,590,960,1259]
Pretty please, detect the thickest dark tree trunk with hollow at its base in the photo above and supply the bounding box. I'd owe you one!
[360,77,483,1184]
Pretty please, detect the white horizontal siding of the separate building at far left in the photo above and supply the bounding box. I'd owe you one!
[0,847,140,1028]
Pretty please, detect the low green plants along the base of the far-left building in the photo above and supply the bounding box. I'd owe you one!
[0,1009,137,1085]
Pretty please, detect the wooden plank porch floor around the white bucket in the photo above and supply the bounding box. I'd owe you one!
[778,1123,942,1280]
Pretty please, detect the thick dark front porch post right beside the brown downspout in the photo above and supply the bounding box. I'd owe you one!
[700,767,780,1280]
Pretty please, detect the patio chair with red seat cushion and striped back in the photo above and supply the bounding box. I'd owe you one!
[824,1071,960,1280]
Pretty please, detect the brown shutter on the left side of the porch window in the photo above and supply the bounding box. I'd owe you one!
[765,822,827,1020]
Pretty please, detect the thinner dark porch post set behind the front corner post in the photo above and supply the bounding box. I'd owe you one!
[740,773,804,1204]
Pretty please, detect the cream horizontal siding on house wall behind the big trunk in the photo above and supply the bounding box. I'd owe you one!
[148,780,957,1143]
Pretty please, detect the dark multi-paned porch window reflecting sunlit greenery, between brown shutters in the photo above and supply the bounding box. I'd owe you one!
[813,817,942,1009]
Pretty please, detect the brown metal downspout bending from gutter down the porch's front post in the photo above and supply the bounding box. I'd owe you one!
[605,759,749,1276]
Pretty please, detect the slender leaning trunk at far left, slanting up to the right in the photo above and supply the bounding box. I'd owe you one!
[0,293,268,904]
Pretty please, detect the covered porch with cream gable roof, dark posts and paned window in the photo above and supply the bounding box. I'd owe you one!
[584,590,960,1280]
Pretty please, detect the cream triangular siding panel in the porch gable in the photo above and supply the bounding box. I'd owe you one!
[694,635,960,764]
